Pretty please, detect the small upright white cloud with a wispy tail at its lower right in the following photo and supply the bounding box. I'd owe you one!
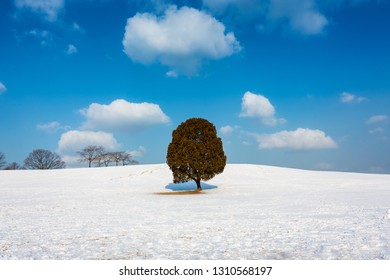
[240,91,286,126]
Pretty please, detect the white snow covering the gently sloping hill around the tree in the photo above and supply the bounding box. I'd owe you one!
[0,164,390,260]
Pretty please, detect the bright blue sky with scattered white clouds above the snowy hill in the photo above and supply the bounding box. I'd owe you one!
[0,0,390,173]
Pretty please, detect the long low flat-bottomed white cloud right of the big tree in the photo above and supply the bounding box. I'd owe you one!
[257,128,337,150]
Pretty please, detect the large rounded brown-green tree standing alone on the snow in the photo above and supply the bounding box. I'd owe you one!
[167,118,226,190]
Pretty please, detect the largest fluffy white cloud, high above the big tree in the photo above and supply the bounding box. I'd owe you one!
[123,6,241,75]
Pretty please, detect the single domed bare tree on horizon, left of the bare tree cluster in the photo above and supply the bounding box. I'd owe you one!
[24,149,65,169]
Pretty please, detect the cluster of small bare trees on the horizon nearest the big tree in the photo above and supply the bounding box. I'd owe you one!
[77,146,138,167]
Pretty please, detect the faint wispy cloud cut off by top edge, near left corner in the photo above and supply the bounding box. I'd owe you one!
[15,0,65,21]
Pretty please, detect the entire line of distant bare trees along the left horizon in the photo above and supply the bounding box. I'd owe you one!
[0,146,138,170]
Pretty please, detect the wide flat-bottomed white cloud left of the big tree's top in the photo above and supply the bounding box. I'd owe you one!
[81,99,170,131]
